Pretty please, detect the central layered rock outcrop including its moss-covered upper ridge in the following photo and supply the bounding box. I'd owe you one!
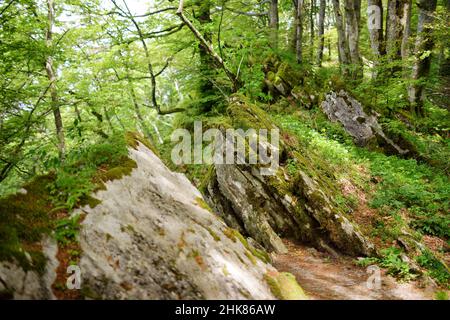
[202,98,374,256]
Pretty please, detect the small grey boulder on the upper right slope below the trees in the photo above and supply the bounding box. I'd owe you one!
[322,90,409,155]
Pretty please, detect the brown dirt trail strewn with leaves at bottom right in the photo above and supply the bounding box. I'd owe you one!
[273,240,433,300]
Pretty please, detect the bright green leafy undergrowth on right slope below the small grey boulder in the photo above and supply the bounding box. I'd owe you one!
[274,112,450,239]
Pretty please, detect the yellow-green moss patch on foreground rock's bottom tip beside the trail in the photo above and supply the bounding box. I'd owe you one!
[264,271,308,300]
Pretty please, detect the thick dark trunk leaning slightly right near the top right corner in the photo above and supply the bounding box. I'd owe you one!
[409,0,437,116]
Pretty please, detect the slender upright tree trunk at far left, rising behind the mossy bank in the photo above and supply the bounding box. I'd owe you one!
[45,0,66,161]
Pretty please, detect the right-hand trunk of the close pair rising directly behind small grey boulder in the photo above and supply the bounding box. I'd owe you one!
[345,0,362,79]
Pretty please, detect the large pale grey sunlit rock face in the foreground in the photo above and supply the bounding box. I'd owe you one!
[75,145,274,299]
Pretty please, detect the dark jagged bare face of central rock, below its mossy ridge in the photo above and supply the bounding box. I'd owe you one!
[206,165,374,256]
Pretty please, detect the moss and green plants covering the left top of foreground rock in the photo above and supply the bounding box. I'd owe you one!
[0,134,148,272]
